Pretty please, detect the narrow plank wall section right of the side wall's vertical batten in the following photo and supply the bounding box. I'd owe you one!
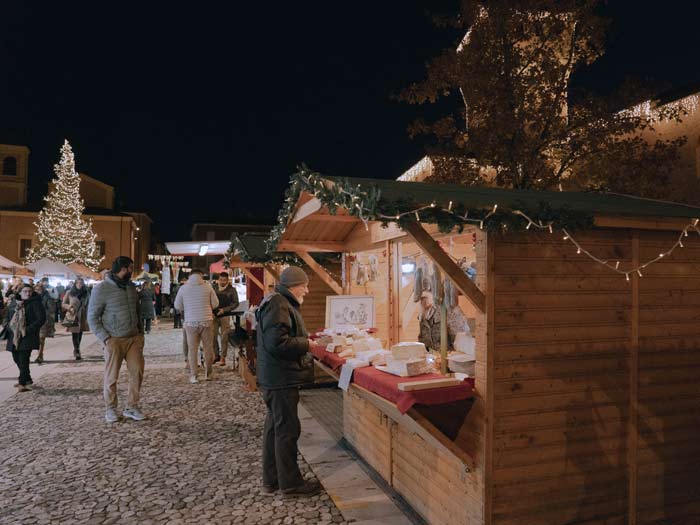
[636,232,700,524]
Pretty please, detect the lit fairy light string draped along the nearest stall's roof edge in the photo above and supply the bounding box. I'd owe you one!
[290,171,700,281]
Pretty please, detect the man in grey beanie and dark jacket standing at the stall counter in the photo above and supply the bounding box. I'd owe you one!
[255,266,320,496]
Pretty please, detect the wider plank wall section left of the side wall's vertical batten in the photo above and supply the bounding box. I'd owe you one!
[490,230,632,525]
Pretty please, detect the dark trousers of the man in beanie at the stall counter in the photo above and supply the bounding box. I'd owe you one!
[260,388,304,490]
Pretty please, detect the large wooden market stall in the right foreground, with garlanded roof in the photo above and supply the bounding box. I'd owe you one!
[271,172,700,525]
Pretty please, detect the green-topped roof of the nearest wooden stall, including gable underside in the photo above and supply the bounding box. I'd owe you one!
[271,176,700,252]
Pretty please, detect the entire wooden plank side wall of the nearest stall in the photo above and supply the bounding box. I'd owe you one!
[491,230,700,525]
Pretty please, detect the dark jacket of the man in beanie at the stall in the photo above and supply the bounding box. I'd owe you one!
[255,285,313,390]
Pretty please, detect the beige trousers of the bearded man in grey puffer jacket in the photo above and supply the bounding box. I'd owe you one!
[104,335,144,409]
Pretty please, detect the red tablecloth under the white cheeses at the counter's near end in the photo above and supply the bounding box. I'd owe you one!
[350,364,474,414]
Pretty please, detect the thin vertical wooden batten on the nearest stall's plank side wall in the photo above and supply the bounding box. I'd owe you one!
[627,230,639,525]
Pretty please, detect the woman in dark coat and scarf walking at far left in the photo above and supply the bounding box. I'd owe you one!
[7,284,46,392]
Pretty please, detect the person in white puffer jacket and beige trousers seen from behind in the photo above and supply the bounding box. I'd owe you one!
[175,270,219,384]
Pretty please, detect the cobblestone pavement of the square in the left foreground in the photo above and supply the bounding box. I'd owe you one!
[0,329,345,525]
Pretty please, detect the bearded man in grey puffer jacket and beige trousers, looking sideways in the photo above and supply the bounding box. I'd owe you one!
[88,255,145,423]
